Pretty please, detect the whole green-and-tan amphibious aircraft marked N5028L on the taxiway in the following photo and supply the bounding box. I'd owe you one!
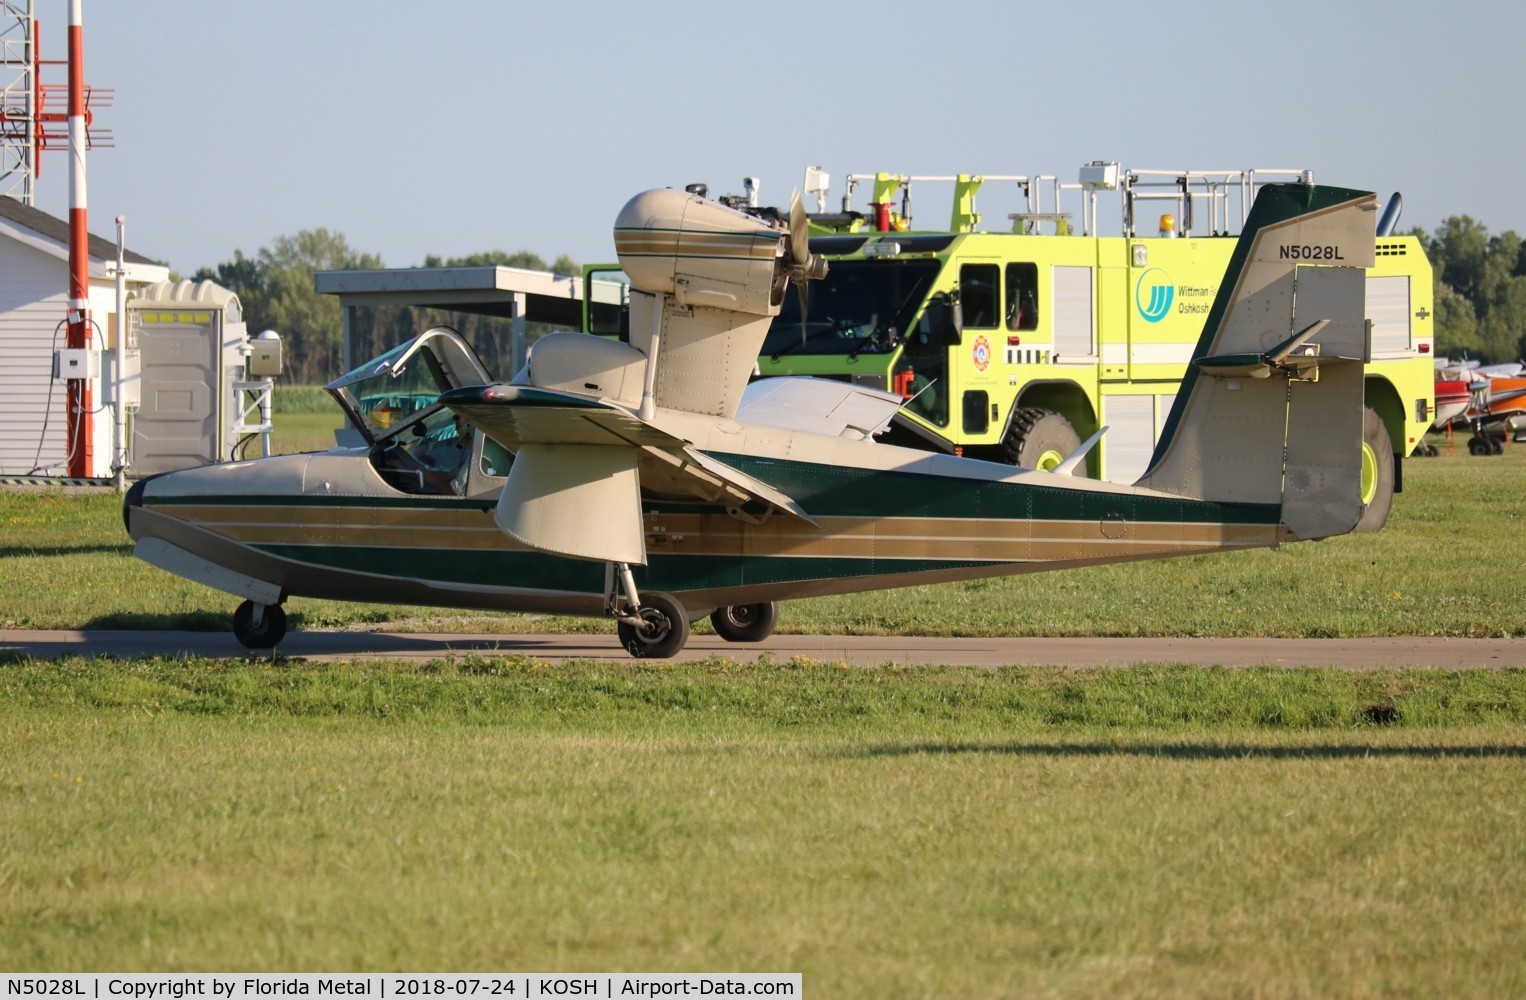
[125,185,1376,656]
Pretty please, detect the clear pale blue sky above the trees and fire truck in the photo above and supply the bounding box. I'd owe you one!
[37,0,1526,275]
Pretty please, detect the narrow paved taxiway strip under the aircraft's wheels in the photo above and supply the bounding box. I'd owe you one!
[0,631,1526,670]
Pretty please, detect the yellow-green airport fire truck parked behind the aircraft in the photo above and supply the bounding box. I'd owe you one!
[589,163,1434,530]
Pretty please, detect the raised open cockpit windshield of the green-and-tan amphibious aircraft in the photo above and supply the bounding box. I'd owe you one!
[327,328,491,443]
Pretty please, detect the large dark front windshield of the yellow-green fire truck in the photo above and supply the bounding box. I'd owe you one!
[761,260,940,357]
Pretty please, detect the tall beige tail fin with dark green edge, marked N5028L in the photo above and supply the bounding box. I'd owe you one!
[1137,185,1378,539]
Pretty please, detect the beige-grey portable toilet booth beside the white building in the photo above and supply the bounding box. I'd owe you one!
[127,281,249,476]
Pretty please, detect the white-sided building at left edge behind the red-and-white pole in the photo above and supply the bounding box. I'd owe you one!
[0,197,169,478]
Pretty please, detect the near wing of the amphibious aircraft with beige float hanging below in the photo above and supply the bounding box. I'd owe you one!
[439,385,815,563]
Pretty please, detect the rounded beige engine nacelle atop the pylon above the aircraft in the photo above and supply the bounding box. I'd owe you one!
[615,188,789,316]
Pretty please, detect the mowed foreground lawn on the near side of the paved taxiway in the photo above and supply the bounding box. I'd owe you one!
[0,658,1526,997]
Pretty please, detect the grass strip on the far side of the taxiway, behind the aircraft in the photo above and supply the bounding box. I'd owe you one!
[0,424,1526,637]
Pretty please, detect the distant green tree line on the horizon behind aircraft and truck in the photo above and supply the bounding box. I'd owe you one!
[194,215,1526,385]
